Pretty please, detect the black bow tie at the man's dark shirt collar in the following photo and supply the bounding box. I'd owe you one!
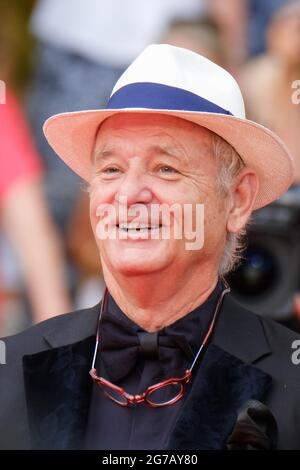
[99,312,193,382]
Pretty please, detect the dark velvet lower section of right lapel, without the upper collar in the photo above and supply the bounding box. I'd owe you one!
[168,345,271,450]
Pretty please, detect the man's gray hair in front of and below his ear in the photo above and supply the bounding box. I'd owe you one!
[211,132,246,276]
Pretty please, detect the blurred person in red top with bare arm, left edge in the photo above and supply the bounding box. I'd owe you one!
[0,2,71,331]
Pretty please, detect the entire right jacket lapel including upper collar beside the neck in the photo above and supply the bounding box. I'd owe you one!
[168,295,272,450]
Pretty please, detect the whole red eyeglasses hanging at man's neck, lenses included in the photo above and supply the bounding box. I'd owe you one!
[90,284,230,408]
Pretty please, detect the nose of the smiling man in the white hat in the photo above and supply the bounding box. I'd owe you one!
[115,172,153,207]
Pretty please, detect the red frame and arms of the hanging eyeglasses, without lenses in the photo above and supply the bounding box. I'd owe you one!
[89,280,230,408]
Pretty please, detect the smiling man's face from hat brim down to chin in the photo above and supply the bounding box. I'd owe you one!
[90,114,226,278]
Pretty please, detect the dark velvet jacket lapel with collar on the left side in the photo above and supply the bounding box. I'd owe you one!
[23,304,99,449]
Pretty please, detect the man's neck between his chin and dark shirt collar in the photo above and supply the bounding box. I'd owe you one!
[103,266,218,332]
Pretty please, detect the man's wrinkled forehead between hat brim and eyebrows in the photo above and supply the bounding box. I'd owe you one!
[93,113,213,165]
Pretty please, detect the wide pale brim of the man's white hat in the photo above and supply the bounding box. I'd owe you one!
[43,108,294,209]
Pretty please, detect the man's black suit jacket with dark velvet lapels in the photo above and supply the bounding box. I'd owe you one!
[0,294,300,450]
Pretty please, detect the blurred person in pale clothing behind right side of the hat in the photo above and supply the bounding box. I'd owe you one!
[241,1,300,184]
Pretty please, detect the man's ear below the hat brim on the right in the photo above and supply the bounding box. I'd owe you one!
[227,168,259,233]
